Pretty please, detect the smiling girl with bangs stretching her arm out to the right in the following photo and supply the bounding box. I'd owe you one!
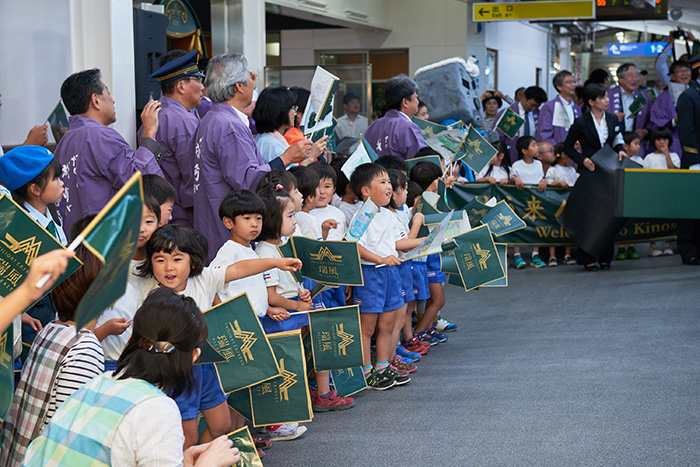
[139,224,301,449]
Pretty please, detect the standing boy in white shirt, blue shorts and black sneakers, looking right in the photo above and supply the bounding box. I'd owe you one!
[350,163,410,391]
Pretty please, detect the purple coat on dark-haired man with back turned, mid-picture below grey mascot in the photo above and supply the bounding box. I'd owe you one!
[364,109,426,160]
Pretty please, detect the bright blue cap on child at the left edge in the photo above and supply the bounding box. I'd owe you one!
[0,146,55,191]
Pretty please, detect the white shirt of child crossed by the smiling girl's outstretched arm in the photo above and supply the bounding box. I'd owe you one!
[211,240,267,317]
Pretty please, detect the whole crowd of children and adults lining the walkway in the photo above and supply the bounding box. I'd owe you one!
[0,31,700,466]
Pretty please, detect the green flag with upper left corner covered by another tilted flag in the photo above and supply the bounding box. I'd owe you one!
[248,329,313,426]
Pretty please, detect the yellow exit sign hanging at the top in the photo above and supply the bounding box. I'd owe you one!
[472,0,595,21]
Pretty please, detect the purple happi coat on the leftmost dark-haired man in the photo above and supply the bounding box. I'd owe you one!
[55,115,163,233]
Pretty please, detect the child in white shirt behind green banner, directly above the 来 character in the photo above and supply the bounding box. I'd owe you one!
[510,136,547,269]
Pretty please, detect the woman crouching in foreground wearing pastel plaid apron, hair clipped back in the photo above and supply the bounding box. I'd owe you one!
[23,288,240,467]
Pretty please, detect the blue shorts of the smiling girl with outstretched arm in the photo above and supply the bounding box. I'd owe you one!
[175,363,226,420]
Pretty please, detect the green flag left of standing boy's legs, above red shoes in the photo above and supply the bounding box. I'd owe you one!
[309,305,363,371]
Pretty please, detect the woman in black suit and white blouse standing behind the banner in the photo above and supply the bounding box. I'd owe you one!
[564,83,627,271]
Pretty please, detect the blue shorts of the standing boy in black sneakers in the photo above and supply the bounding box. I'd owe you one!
[353,264,404,313]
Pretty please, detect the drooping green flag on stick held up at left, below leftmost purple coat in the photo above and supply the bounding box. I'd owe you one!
[75,172,143,329]
